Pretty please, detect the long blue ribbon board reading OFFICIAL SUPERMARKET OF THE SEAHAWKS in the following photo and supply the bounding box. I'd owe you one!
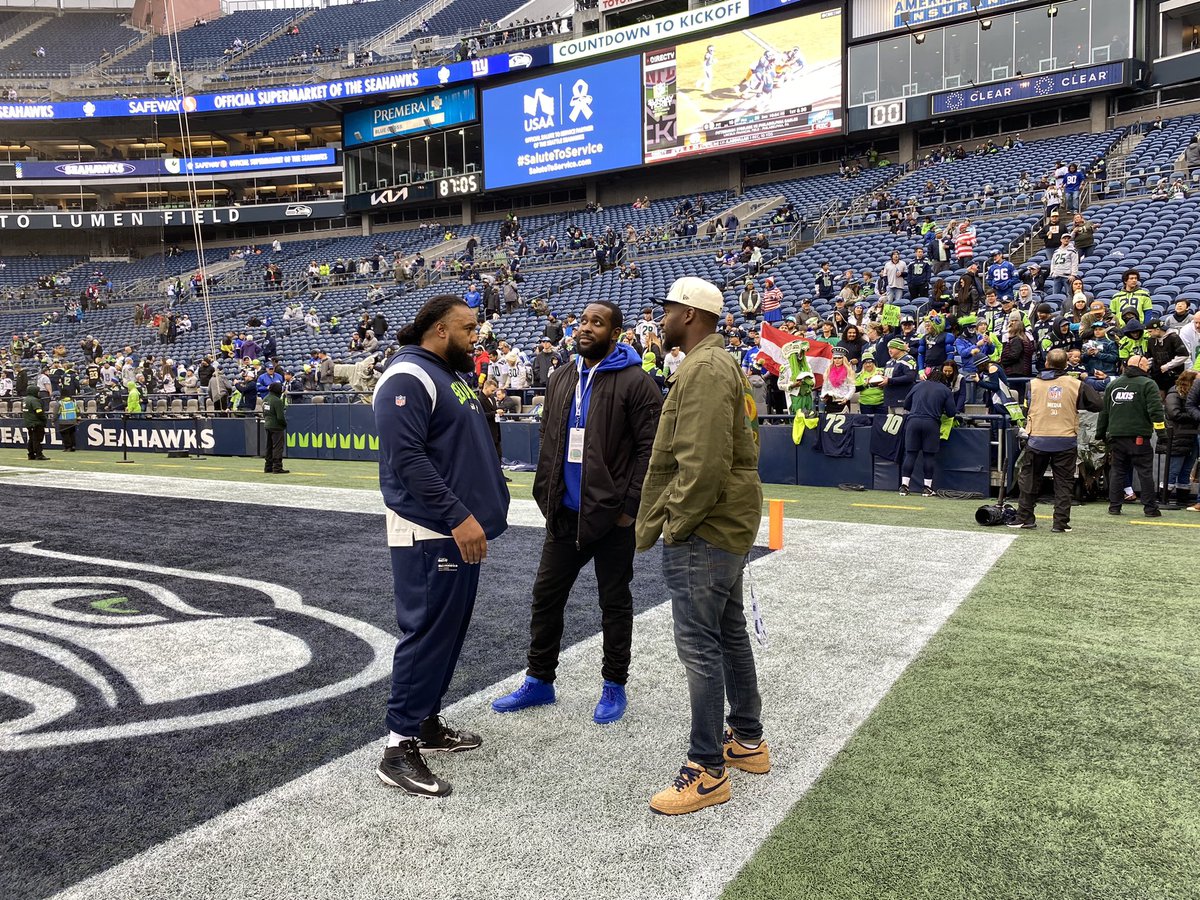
[0,46,551,121]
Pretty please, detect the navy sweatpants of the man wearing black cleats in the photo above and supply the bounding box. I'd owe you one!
[388,538,479,737]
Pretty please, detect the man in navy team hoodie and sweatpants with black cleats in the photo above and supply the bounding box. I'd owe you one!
[373,294,509,797]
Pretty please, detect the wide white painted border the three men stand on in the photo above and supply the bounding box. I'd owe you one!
[60,520,1012,900]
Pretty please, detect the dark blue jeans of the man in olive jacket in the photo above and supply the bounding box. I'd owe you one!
[662,534,762,768]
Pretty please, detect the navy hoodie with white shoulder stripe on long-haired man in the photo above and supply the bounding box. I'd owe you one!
[373,347,509,540]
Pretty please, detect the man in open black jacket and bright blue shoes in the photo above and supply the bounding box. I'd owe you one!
[492,300,662,725]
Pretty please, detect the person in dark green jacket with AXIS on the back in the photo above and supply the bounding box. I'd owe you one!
[1096,355,1166,518]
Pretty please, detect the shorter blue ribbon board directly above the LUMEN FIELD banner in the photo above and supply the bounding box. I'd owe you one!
[14,148,337,181]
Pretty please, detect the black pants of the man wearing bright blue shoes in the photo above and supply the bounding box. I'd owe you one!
[528,509,635,684]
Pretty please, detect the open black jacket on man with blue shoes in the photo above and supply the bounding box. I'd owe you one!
[533,365,662,545]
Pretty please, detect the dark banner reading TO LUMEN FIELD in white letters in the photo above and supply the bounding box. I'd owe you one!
[0,200,346,232]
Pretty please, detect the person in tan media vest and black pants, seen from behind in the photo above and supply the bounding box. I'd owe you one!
[1009,348,1104,534]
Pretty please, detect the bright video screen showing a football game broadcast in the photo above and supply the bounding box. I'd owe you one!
[642,8,842,162]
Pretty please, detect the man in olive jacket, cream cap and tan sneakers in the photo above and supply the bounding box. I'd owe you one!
[637,277,770,815]
